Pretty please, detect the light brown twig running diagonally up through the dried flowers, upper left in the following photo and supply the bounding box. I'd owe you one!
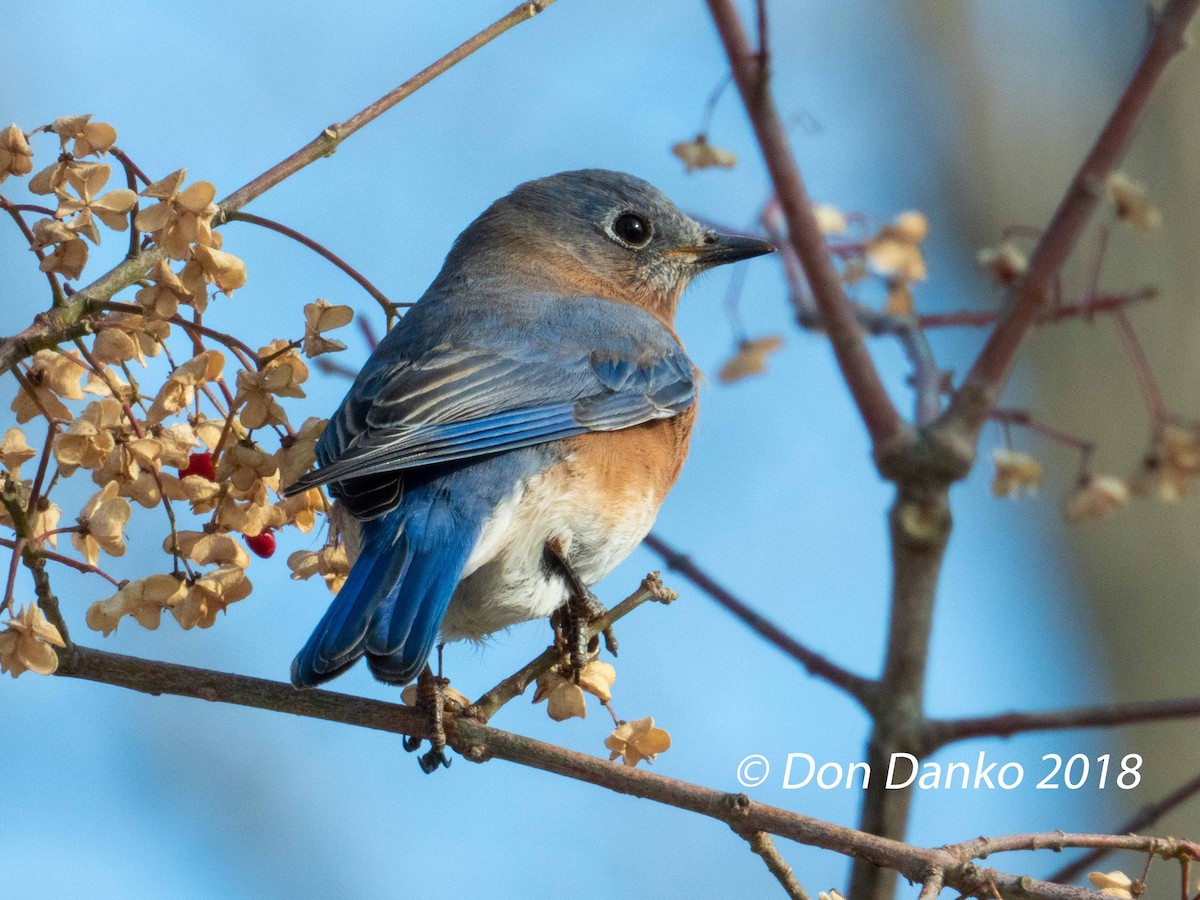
[0,0,554,374]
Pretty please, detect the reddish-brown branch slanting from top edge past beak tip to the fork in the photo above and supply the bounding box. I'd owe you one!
[708,0,906,451]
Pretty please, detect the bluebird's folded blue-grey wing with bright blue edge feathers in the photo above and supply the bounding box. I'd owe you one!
[288,301,696,493]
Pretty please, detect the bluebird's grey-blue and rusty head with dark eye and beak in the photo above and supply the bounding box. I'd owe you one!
[443,169,774,322]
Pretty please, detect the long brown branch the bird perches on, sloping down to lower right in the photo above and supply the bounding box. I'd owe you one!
[49,646,1200,900]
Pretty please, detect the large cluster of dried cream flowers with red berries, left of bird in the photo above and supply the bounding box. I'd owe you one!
[0,115,353,676]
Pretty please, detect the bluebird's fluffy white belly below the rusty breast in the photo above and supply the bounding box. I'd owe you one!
[442,469,661,641]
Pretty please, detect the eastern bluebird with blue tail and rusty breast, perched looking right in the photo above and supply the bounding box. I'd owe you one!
[286,169,773,688]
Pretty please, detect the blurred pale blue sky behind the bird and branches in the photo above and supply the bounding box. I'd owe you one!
[0,0,1150,899]
